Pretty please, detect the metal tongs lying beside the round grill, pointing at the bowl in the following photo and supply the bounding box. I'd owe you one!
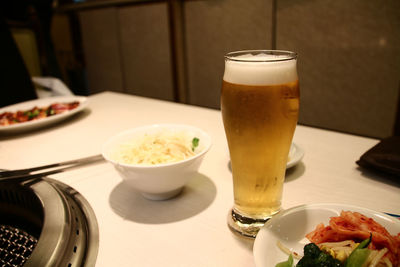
[0,155,103,182]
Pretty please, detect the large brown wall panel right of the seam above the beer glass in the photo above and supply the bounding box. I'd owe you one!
[277,0,400,138]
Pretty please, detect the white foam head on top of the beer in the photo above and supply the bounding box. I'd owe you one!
[224,51,298,85]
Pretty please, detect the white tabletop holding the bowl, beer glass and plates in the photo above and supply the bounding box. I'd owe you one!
[0,92,400,267]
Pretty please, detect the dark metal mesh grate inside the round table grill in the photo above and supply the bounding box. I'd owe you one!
[0,225,37,267]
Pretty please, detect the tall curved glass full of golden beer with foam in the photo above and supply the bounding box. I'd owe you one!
[221,50,300,237]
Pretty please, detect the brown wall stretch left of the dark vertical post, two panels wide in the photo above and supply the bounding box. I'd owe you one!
[79,3,173,100]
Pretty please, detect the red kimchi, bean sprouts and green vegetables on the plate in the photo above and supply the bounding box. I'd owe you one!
[276,211,400,267]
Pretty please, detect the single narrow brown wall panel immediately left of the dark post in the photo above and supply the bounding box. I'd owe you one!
[118,3,174,100]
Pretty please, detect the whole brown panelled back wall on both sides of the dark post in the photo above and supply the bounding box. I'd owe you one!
[76,0,400,138]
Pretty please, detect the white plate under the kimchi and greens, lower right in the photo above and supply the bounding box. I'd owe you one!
[253,203,400,267]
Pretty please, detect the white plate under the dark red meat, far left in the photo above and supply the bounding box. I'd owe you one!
[0,96,88,133]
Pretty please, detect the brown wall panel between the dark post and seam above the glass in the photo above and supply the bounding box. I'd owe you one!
[184,0,272,108]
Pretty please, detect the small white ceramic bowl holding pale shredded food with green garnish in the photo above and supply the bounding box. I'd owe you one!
[102,124,211,200]
